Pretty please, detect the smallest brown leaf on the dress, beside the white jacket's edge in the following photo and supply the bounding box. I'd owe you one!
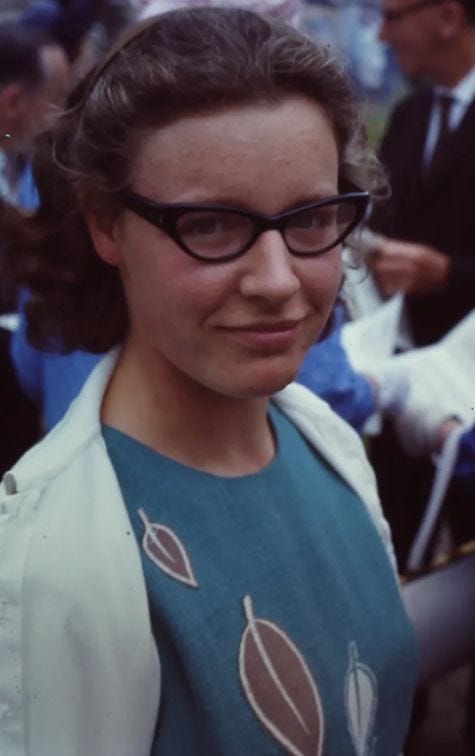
[138,508,198,588]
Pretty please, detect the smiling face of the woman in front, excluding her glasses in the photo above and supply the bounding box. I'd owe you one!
[96,97,342,398]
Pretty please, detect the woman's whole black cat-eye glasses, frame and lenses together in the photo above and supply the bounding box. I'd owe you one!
[121,184,369,263]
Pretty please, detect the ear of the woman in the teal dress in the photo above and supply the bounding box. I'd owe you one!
[79,189,122,266]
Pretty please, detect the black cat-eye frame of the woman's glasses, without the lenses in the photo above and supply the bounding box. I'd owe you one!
[120,182,369,263]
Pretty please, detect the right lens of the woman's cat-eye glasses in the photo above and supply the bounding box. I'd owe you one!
[285,201,356,253]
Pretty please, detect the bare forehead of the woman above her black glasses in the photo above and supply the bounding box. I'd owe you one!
[128,97,338,208]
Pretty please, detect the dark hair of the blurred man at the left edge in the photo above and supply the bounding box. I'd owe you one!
[0,22,48,89]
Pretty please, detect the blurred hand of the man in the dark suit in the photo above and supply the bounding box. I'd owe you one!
[368,239,450,296]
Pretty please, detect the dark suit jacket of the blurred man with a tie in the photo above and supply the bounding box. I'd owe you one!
[370,89,475,346]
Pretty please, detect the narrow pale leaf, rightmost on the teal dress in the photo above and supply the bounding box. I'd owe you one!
[345,641,378,756]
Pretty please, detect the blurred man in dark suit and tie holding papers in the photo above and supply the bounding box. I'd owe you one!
[371,0,475,346]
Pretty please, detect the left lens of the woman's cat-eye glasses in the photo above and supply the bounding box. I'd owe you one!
[176,210,254,260]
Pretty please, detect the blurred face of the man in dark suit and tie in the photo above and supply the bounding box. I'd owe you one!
[379,0,450,80]
